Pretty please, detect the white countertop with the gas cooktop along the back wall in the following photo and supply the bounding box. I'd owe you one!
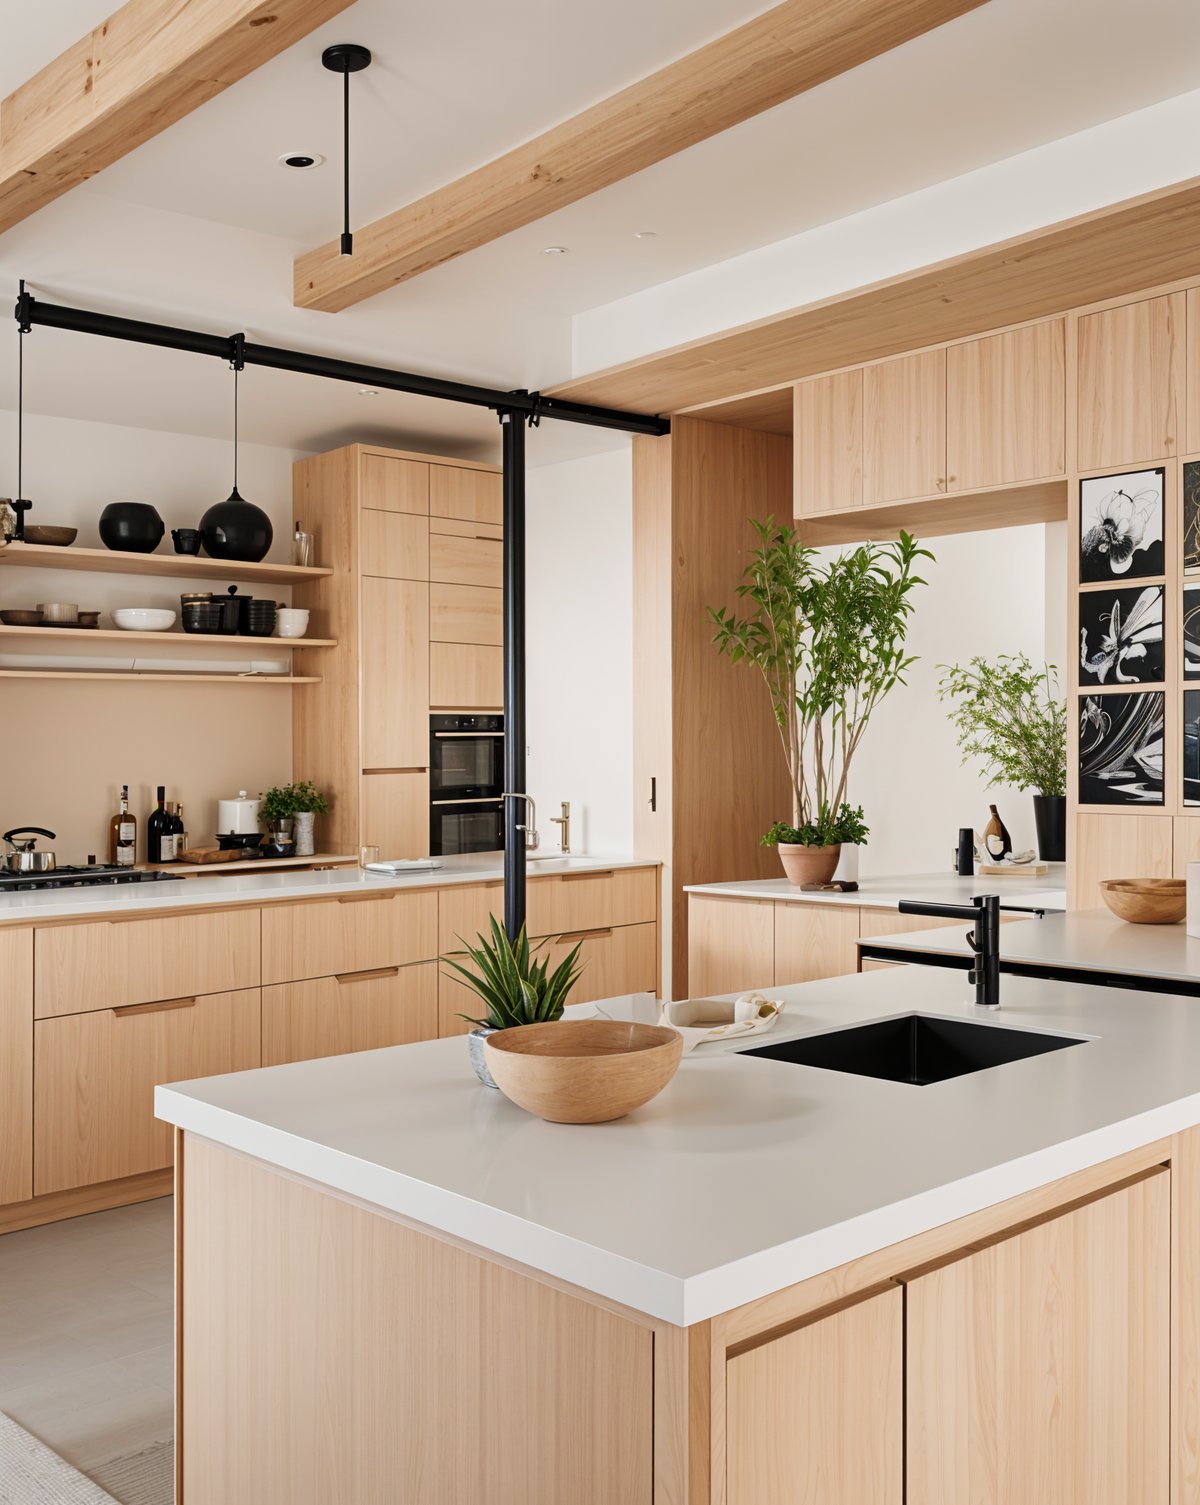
[0,852,655,926]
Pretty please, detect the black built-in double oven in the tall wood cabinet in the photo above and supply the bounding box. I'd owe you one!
[429,715,504,856]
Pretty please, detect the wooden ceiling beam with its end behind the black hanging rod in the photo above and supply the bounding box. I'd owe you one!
[294,0,986,313]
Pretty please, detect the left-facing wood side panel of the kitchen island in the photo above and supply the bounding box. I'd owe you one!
[176,1136,655,1505]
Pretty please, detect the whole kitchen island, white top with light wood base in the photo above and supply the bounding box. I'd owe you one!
[157,969,1200,1505]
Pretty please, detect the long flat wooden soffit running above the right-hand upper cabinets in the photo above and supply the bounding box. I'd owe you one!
[547,178,1200,415]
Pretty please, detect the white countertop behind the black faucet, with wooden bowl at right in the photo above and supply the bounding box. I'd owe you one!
[861,909,1200,993]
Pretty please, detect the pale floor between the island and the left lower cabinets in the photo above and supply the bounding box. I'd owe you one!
[0,1196,175,1473]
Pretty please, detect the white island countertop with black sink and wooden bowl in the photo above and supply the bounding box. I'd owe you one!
[155,968,1200,1326]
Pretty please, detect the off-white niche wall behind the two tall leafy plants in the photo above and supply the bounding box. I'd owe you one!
[831,524,1066,876]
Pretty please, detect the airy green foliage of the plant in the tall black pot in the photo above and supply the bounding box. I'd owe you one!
[938,653,1066,795]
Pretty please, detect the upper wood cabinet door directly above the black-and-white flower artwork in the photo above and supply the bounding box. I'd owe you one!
[1078,292,1185,470]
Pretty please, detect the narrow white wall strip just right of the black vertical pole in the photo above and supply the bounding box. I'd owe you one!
[525,444,635,876]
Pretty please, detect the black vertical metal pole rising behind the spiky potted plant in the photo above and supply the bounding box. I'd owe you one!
[500,412,528,939]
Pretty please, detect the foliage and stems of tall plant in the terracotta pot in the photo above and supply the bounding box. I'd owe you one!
[709,518,934,846]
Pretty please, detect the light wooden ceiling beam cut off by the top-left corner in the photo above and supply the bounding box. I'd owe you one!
[0,0,352,233]
